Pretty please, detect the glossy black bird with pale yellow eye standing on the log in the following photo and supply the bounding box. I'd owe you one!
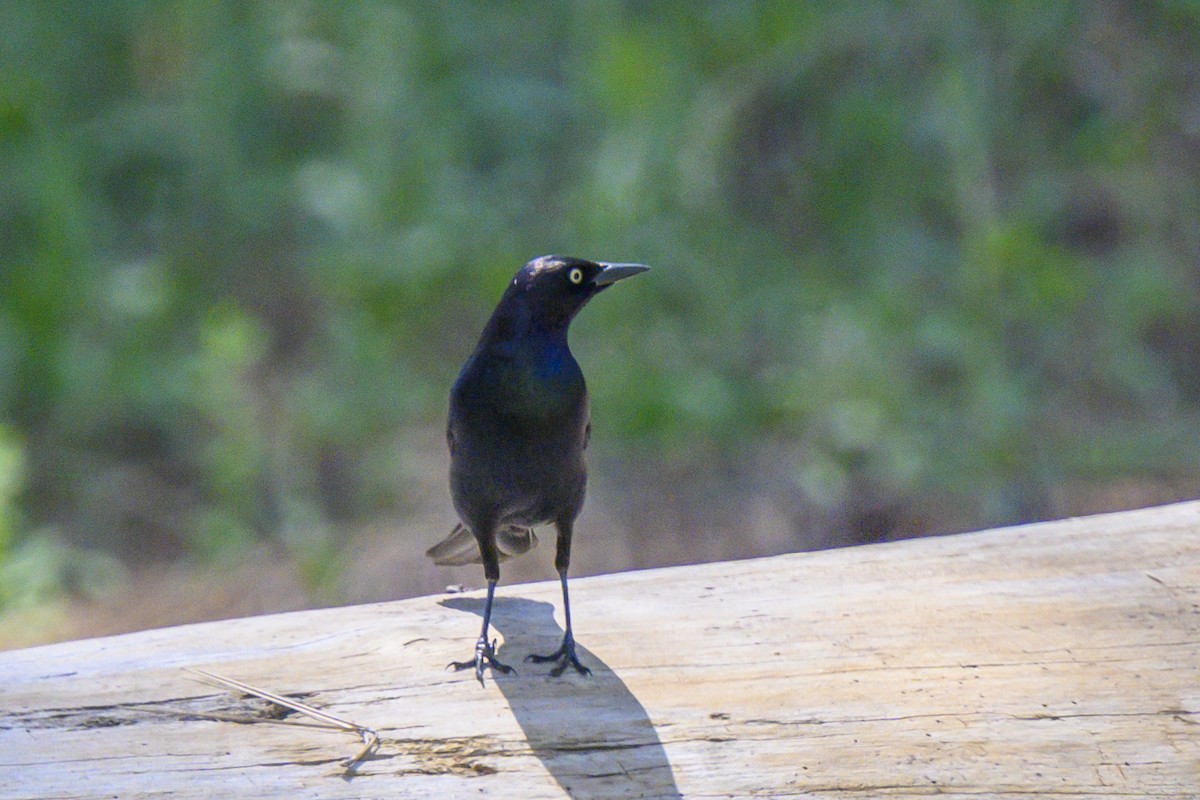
[426,255,649,685]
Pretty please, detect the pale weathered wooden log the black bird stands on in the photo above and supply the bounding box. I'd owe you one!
[0,503,1200,800]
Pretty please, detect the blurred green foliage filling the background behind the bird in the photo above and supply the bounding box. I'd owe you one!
[0,0,1200,604]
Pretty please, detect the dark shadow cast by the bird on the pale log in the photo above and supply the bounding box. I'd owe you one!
[440,597,680,800]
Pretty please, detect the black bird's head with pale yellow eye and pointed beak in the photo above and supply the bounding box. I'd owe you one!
[497,255,650,338]
